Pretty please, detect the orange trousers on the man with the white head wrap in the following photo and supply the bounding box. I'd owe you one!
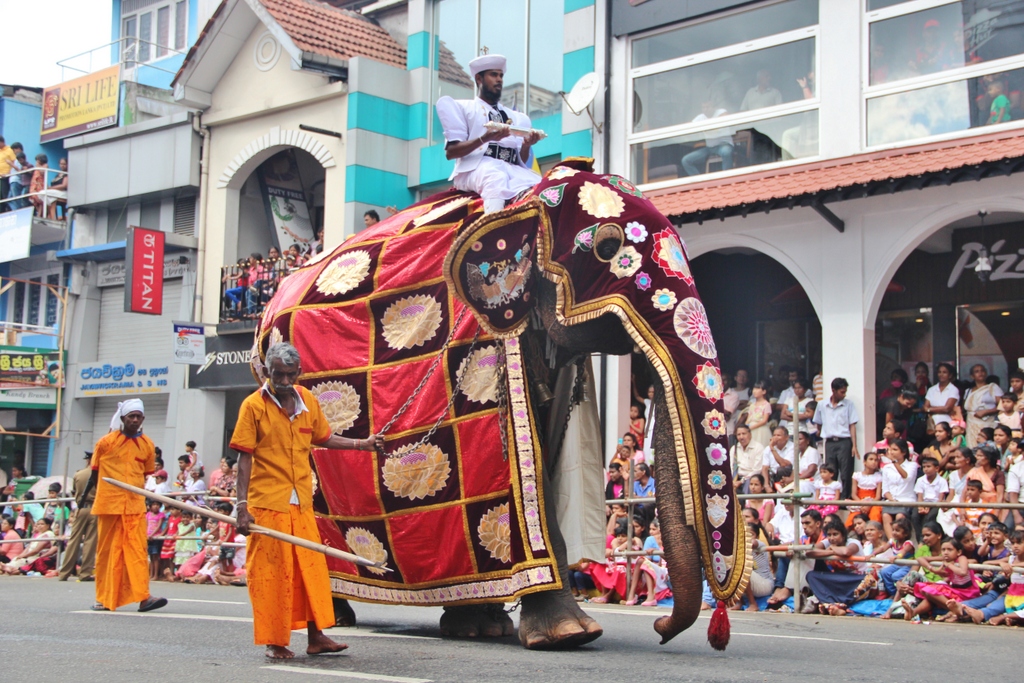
[96,514,150,609]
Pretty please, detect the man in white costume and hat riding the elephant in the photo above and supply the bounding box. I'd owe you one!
[436,54,541,213]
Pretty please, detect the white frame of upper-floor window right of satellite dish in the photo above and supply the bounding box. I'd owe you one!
[624,0,823,190]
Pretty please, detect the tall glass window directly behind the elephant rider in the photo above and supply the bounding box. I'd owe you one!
[430,0,564,142]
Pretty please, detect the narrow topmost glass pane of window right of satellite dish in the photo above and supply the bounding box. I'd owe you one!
[633,0,818,68]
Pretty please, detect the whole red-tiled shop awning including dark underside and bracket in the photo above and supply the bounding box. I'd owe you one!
[646,131,1024,231]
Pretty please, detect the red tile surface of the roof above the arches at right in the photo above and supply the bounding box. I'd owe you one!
[644,131,1024,217]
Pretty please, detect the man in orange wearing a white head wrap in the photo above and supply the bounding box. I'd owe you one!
[82,398,167,612]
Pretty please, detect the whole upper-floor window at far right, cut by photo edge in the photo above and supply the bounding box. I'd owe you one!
[864,0,1024,146]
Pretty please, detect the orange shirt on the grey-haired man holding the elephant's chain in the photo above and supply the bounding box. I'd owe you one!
[230,386,331,512]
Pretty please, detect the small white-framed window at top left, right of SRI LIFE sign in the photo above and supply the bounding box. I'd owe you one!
[121,0,188,67]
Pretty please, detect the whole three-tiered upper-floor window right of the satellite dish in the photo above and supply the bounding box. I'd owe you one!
[628,0,818,183]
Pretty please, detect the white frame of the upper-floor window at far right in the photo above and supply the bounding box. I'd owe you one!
[860,0,1024,152]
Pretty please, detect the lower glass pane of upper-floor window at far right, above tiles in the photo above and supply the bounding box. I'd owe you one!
[867,69,1024,146]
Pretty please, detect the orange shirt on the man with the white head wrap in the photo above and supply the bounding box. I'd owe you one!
[91,430,157,515]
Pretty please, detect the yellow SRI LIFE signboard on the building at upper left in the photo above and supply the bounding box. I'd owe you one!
[39,66,121,142]
